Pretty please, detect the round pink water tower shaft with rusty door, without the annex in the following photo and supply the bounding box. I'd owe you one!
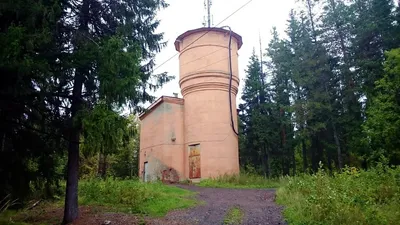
[175,28,242,179]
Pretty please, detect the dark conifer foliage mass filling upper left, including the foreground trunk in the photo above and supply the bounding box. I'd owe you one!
[0,0,172,222]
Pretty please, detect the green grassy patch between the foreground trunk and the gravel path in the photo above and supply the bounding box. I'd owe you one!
[79,178,196,216]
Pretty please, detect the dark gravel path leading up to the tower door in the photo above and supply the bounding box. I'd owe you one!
[150,185,286,225]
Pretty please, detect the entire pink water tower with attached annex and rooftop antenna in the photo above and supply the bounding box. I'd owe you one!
[139,0,242,182]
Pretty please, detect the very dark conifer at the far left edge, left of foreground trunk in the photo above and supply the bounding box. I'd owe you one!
[0,0,66,200]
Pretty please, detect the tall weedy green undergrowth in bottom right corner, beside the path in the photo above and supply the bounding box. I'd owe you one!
[277,164,400,224]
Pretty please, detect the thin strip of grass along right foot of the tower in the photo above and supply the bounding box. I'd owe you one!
[198,172,286,189]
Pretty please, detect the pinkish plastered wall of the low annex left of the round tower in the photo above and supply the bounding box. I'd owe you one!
[139,97,184,180]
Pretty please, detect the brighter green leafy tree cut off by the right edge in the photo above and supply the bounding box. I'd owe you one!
[364,49,400,165]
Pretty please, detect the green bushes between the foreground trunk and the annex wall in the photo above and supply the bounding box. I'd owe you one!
[79,114,139,179]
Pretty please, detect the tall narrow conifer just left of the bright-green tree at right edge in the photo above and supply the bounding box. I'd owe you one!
[322,0,362,168]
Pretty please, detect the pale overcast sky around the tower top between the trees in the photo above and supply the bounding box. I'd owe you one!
[151,0,296,102]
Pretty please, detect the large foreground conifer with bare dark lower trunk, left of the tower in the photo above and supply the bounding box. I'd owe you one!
[51,0,171,223]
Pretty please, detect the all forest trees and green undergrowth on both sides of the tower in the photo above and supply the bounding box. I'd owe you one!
[0,0,400,224]
